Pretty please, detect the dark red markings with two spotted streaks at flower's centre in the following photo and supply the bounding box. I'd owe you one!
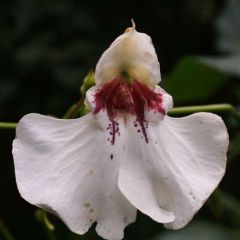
[94,77,165,145]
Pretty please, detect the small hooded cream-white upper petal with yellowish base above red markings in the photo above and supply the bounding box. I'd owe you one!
[95,29,161,85]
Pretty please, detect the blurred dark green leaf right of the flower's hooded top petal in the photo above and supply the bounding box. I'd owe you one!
[164,57,228,104]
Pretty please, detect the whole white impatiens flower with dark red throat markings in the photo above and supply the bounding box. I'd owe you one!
[13,23,228,240]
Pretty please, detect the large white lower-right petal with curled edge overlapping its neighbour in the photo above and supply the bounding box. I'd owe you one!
[118,113,228,229]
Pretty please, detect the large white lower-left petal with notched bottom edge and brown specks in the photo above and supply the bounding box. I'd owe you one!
[13,114,136,240]
